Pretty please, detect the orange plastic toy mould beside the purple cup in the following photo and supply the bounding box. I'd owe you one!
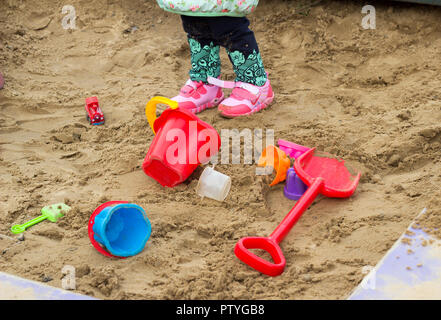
[257,145,291,187]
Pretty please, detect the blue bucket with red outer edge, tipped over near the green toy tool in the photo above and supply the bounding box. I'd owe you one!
[93,203,152,257]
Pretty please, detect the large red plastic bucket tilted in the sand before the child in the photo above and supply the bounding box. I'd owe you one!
[142,98,221,187]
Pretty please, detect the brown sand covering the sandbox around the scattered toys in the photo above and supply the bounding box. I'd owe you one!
[0,0,441,299]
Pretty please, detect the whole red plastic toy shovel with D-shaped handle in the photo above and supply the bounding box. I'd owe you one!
[234,148,360,277]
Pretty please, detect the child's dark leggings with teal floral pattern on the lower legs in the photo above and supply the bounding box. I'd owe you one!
[181,15,267,86]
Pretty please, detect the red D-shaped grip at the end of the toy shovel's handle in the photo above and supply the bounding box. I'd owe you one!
[234,237,286,277]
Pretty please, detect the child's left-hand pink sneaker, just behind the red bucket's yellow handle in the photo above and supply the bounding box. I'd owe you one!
[172,80,224,113]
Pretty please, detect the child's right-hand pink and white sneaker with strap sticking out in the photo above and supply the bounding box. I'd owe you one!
[208,78,274,118]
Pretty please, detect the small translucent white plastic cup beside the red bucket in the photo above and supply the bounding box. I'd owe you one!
[196,167,231,201]
